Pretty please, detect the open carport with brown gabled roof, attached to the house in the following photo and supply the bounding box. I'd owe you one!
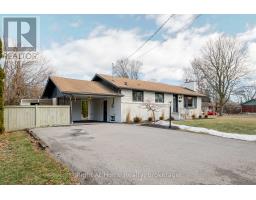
[42,77,122,122]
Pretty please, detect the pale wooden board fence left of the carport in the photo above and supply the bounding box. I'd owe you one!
[4,106,70,131]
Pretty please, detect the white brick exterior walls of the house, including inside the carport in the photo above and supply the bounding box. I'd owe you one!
[89,89,201,122]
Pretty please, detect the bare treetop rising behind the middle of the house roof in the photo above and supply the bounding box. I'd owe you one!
[112,58,142,80]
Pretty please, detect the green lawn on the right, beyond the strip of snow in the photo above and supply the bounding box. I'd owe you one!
[175,115,256,135]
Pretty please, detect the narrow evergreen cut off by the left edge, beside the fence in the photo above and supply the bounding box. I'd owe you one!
[0,38,4,133]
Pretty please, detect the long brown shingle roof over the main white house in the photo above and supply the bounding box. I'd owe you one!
[96,74,204,96]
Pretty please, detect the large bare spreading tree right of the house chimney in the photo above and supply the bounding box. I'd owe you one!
[191,36,247,115]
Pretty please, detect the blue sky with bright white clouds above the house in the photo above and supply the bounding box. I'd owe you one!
[0,15,256,84]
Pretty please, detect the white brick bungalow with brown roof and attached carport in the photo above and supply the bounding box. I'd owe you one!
[42,74,204,122]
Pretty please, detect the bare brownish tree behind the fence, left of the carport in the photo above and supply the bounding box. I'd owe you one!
[4,48,53,105]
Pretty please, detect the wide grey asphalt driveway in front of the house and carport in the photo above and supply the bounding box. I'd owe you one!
[33,123,256,184]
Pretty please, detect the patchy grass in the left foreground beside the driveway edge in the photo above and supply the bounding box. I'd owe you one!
[0,131,77,184]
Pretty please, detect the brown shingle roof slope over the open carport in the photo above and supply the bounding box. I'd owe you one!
[50,76,120,96]
